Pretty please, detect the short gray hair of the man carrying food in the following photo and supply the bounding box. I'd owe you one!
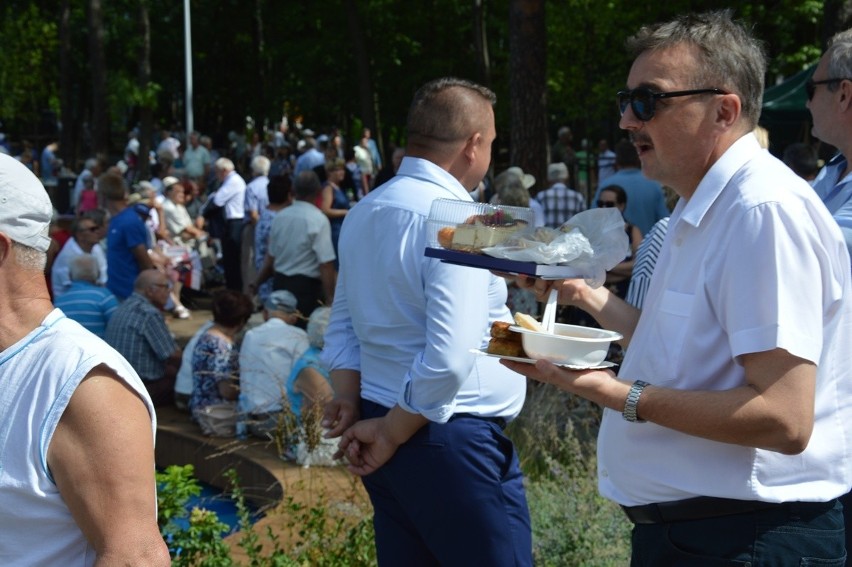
[627,10,766,130]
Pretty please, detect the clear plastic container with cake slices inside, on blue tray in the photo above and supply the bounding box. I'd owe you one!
[427,199,534,253]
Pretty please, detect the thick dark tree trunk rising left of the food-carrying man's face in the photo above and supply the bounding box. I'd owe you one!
[509,0,548,195]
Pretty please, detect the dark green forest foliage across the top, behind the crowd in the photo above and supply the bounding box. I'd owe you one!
[0,0,833,157]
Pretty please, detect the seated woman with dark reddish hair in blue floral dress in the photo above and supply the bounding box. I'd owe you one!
[189,290,254,428]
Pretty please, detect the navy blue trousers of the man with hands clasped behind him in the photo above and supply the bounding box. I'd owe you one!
[361,400,532,567]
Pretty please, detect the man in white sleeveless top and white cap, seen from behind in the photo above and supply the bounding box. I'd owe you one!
[0,155,170,566]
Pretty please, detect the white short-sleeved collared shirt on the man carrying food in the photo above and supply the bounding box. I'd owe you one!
[598,135,852,506]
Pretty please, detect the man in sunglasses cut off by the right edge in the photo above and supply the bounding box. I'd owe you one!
[805,29,852,262]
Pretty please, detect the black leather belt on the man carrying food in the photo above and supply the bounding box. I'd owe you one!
[621,496,833,524]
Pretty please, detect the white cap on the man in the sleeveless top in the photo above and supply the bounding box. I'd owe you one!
[0,154,53,252]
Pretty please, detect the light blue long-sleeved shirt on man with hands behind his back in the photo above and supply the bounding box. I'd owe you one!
[323,157,526,422]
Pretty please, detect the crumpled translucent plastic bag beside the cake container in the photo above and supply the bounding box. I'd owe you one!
[482,208,630,287]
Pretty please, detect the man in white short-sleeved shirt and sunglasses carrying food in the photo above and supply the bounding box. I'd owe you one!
[503,11,852,566]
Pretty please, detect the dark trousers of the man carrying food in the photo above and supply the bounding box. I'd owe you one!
[630,500,846,567]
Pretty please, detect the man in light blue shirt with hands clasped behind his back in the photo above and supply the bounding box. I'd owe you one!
[323,79,532,566]
